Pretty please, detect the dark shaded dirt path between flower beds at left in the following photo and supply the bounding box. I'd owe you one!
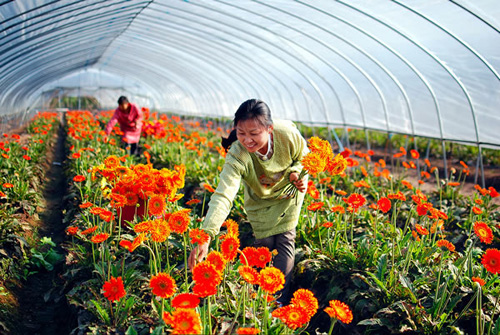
[13,122,76,335]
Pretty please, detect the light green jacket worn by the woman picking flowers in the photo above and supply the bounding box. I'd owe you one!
[202,120,309,239]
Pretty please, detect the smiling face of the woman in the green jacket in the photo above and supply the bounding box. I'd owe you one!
[236,119,273,154]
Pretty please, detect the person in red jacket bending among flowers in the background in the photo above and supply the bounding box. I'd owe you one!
[106,96,143,155]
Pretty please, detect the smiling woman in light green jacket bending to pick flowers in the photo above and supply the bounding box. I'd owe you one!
[189,99,308,304]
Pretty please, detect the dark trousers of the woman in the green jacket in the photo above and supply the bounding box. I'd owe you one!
[254,229,296,305]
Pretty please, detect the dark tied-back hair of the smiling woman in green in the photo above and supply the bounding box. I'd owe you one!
[221,99,273,152]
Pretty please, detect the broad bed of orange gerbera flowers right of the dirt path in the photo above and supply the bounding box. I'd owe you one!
[61,112,500,334]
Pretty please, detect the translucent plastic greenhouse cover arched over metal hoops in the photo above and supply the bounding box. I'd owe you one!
[0,0,500,147]
